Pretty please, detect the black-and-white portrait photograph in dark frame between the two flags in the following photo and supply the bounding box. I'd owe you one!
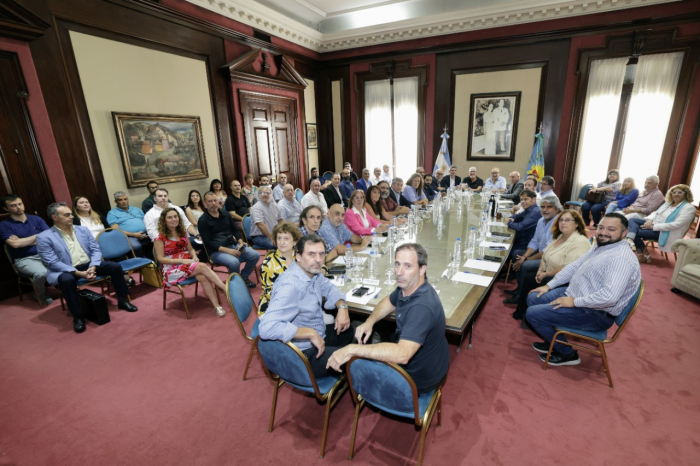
[467,91,521,161]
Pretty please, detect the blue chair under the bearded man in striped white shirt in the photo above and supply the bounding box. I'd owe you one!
[542,280,644,388]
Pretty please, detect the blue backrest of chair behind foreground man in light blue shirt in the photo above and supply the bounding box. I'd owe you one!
[258,340,321,397]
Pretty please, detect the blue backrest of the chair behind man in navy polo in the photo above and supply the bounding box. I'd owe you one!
[346,358,420,424]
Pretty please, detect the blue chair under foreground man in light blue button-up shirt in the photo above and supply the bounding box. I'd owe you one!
[258,340,348,458]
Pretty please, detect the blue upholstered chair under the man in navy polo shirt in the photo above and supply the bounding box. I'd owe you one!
[346,358,446,465]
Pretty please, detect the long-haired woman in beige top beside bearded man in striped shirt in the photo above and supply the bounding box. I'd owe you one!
[513,210,591,320]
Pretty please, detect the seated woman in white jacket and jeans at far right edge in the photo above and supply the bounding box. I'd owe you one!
[627,184,695,264]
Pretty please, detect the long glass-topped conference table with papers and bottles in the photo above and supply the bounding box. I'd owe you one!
[336,195,514,347]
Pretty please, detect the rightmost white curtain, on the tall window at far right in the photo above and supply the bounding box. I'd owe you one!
[620,52,683,187]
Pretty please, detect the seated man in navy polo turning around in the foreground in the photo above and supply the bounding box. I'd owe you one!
[326,243,450,393]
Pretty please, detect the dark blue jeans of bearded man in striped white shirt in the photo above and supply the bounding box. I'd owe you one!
[525,286,615,355]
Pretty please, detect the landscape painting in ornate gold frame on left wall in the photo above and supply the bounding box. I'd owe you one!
[112,112,208,188]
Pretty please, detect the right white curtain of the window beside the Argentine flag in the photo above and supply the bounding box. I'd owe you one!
[394,77,418,183]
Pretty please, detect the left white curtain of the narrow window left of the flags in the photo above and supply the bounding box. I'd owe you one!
[366,79,393,176]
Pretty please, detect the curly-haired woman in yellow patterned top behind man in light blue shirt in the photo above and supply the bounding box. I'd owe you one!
[258,222,301,316]
